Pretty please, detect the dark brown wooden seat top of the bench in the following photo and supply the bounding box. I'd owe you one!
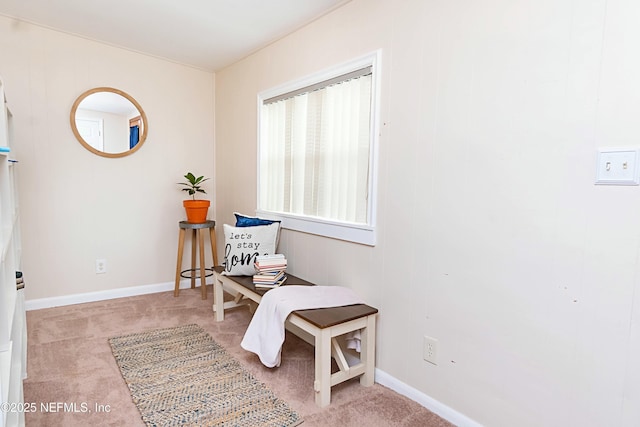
[214,266,378,329]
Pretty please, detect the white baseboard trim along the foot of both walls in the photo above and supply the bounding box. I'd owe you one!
[30,281,482,427]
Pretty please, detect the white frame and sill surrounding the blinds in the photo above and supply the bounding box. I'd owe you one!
[256,50,382,246]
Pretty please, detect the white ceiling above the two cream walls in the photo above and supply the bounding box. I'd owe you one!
[0,0,350,71]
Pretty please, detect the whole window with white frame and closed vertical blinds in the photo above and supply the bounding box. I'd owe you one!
[258,54,378,245]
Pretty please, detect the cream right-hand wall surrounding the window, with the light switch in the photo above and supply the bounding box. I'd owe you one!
[216,0,640,426]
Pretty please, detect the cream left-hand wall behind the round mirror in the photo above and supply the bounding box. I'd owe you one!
[0,17,214,300]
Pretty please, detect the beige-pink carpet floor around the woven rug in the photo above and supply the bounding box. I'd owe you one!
[24,289,451,427]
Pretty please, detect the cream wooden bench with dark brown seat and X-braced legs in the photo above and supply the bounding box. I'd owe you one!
[213,267,378,407]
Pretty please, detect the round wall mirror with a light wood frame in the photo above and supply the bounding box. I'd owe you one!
[71,87,148,157]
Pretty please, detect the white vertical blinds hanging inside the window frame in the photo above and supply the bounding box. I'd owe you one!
[259,67,372,224]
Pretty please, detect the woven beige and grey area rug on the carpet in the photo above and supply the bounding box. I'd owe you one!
[109,324,302,427]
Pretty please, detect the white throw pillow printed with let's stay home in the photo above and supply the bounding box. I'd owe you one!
[222,222,280,276]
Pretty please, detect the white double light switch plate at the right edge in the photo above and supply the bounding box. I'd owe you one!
[596,148,640,185]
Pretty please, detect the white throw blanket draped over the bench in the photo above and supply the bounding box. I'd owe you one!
[240,285,364,368]
